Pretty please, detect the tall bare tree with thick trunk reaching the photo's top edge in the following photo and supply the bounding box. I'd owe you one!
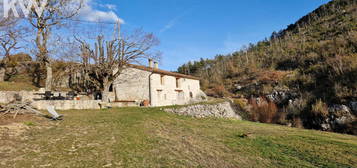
[28,0,83,90]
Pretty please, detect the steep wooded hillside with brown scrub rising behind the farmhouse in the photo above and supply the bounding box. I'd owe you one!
[178,0,357,132]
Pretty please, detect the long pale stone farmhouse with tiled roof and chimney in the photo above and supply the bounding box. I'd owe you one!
[111,60,207,106]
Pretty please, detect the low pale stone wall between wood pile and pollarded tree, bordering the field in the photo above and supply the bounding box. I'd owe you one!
[32,100,101,110]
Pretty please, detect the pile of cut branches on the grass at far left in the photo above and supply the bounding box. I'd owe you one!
[0,101,43,118]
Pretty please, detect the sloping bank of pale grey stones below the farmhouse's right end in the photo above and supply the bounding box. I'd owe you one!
[165,102,242,120]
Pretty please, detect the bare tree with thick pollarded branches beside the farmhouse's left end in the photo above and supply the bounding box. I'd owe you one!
[78,30,159,102]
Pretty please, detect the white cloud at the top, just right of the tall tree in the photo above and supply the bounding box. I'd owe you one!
[80,0,124,24]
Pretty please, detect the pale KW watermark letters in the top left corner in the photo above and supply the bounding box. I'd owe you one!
[0,0,48,18]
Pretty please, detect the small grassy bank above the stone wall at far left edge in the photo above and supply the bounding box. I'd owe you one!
[0,82,39,91]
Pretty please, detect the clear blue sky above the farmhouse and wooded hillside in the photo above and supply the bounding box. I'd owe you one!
[84,0,329,70]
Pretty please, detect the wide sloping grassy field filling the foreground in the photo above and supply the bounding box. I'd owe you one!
[0,108,357,168]
